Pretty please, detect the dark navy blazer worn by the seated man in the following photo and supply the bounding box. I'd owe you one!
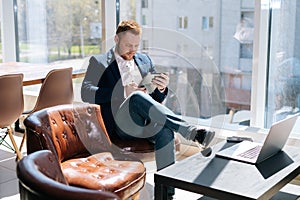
[81,48,168,137]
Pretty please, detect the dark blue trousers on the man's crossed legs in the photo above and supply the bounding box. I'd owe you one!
[115,91,194,170]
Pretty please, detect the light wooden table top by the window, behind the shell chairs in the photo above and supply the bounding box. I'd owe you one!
[0,62,86,86]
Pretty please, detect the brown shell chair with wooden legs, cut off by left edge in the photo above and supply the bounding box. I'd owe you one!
[0,74,24,160]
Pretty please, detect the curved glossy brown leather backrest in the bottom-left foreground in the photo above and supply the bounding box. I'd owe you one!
[17,150,119,200]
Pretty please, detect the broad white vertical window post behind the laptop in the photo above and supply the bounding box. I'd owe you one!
[250,0,270,127]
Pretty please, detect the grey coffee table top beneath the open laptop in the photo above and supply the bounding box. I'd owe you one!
[154,142,300,199]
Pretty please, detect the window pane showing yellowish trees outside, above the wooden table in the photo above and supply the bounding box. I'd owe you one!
[17,0,102,63]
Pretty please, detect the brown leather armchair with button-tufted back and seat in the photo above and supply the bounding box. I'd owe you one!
[24,104,146,199]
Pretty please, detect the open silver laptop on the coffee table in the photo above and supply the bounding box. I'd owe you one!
[216,114,298,164]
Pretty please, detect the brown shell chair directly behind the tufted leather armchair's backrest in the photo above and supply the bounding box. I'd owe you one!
[20,67,74,150]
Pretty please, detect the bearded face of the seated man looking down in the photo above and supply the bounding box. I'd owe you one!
[115,31,141,60]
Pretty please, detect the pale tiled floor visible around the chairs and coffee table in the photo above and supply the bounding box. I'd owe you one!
[0,129,201,200]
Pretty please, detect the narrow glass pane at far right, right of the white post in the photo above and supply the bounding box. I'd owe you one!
[266,0,300,127]
